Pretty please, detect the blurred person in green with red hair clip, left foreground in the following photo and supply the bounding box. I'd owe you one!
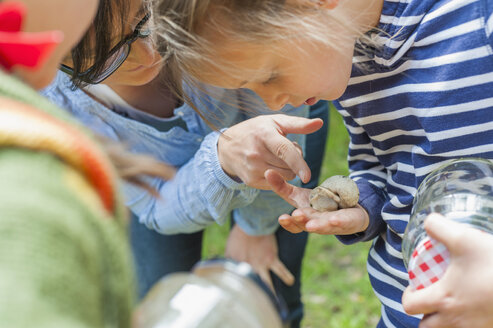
[0,0,172,328]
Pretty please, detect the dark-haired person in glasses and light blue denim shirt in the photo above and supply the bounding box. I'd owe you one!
[43,0,325,327]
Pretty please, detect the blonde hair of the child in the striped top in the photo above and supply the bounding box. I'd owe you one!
[156,0,367,96]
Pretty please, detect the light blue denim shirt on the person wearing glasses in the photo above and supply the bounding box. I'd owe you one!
[41,72,308,235]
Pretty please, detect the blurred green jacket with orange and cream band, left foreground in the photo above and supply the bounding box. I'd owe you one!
[0,73,134,328]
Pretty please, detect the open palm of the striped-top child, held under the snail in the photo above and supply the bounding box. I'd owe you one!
[265,170,370,235]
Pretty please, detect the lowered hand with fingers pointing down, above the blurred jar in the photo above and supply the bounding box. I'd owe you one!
[226,224,294,290]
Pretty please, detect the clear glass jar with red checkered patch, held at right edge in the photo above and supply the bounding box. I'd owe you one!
[402,158,493,289]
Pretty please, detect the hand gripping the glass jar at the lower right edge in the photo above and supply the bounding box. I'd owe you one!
[402,214,493,328]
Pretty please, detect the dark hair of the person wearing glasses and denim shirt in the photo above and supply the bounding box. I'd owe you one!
[71,0,129,87]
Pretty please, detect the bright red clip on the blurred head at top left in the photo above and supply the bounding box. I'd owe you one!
[0,2,63,70]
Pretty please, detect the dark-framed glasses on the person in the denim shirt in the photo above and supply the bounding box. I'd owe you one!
[60,13,151,84]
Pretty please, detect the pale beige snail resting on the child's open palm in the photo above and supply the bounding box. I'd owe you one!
[310,175,359,212]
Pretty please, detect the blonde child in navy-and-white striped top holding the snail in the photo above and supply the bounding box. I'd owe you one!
[160,0,493,327]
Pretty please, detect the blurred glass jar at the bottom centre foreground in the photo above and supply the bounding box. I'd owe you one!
[133,259,287,328]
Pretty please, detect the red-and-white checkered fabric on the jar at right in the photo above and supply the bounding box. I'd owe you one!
[408,236,450,289]
